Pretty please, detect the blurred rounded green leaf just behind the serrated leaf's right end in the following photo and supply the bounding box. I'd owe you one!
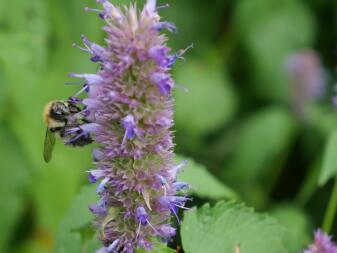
[271,204,312,252]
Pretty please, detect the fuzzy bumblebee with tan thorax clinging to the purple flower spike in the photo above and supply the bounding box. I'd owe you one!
[43,100,93,162]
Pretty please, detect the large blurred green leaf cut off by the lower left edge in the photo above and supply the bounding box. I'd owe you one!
[0,122,29,252]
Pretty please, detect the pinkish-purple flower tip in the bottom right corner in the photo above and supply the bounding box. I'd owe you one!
[303,229,337,253]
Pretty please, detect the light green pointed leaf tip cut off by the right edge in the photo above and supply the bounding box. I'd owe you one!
[318,130,337,186]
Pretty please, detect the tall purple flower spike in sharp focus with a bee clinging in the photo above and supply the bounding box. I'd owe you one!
[66,0,188,253]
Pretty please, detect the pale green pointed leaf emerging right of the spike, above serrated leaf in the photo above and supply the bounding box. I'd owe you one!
[176,157,238,199]
